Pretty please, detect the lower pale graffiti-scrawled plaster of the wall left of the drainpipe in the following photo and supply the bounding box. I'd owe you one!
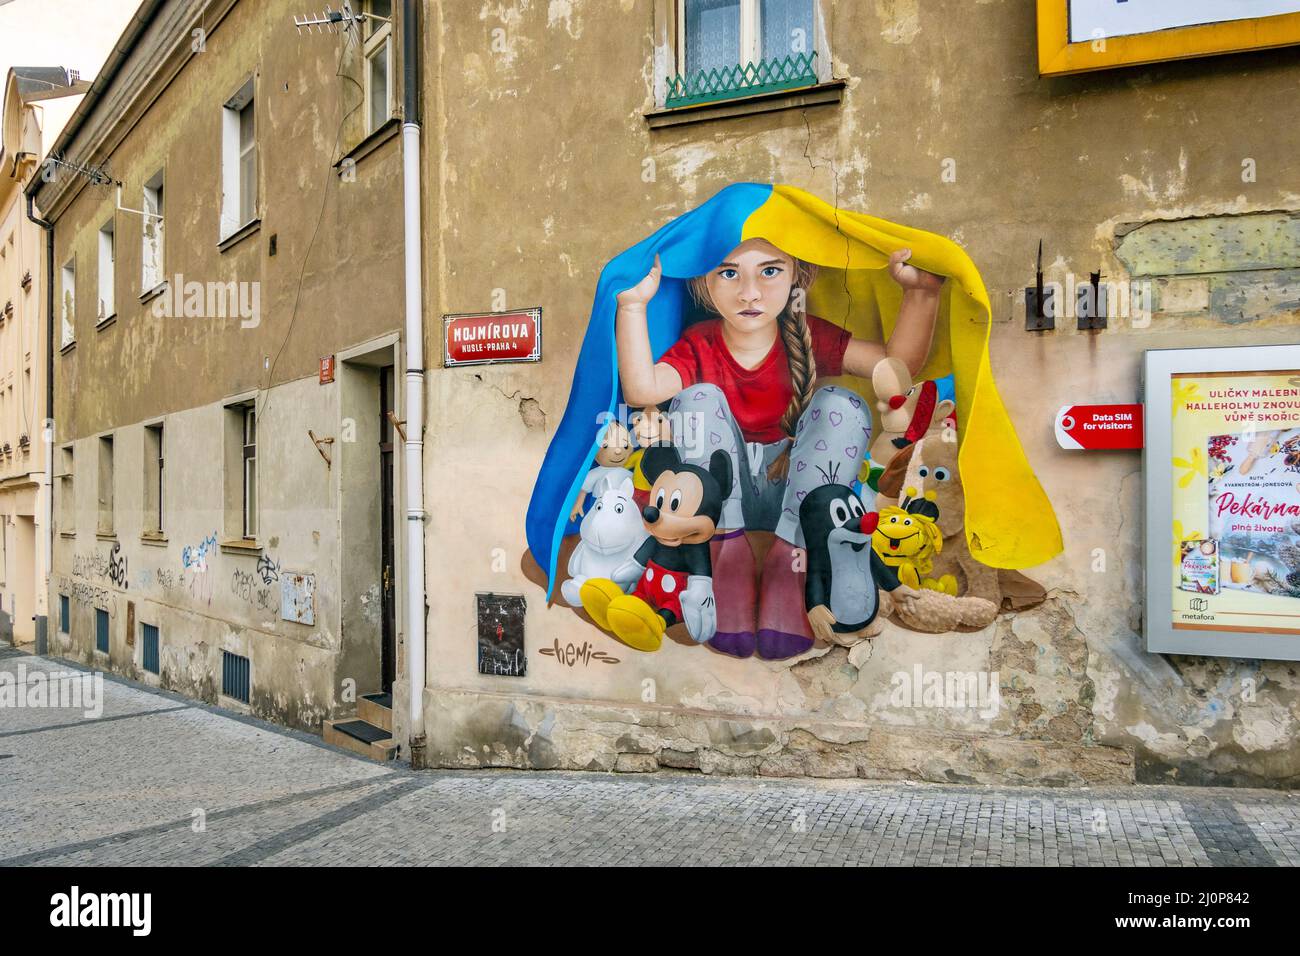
[52,378,351,728]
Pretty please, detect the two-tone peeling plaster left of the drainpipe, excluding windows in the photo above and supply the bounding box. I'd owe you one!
[51,0,402,730]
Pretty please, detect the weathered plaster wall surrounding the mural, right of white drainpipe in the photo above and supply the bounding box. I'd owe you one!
[425,0,1300,786]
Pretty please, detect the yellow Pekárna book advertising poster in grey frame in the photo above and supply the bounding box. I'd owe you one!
[1170,369,1300,635]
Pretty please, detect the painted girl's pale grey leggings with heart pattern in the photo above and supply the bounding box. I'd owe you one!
[668,384,871,548]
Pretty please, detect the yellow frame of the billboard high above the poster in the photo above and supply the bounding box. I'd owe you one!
[1037,0,1300,77]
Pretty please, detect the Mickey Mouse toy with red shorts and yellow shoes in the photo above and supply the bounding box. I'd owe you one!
[579,445,732,650]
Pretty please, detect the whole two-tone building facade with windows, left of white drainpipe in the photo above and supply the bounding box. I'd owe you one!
[35,0,403,731]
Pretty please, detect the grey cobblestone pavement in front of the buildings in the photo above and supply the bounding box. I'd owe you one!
[0,649,1300,866]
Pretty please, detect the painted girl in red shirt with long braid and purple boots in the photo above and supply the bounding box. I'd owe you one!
[615,238,944,659]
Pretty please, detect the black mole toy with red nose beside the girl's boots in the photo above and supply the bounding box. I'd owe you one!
[800,484,914,645]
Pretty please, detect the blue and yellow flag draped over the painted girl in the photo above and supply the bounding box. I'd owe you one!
[527,183,1062,588]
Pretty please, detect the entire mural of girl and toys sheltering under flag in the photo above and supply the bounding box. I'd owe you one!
[525,183,1062,663]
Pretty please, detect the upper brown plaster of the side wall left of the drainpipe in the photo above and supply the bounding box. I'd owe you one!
[47,1,402,429]
